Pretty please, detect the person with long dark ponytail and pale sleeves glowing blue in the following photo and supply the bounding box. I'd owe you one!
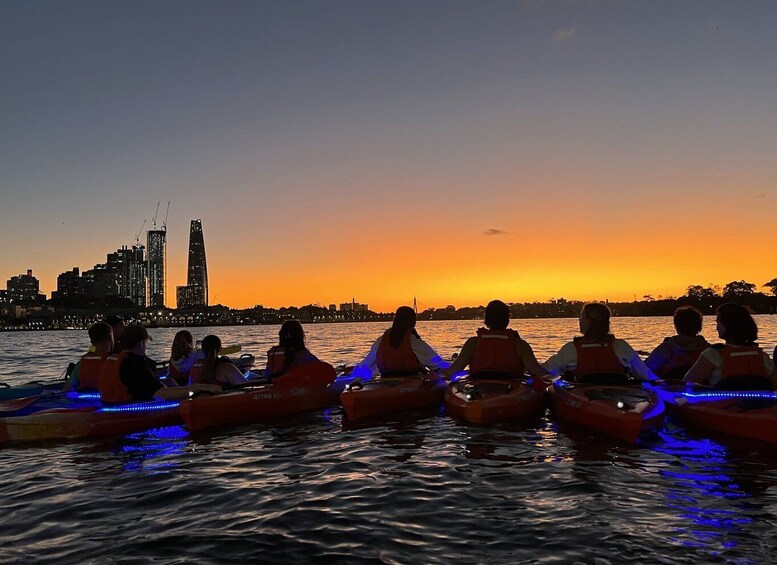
[353,306,448,377]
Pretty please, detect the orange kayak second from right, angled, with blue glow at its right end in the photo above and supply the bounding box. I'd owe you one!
[547,379,665,443]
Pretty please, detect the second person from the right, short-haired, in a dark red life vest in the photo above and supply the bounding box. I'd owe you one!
[645,306,710,379]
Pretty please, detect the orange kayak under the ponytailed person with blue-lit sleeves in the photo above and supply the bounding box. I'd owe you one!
[340,375,448,421]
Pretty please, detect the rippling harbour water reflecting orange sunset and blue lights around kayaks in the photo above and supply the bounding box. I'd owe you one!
[0,316,777,564]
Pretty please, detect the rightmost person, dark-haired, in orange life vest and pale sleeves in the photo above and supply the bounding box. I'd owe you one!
[683,302,777,390]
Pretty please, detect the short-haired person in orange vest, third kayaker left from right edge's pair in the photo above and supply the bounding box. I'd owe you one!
[442,300,548,378]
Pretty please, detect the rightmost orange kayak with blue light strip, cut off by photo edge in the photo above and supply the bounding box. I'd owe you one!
[661,384,777,443]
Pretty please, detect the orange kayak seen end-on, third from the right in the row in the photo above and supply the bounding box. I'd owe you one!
[445,379,545,424]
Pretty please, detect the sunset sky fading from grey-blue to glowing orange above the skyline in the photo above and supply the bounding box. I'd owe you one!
[0,0,777,311]
